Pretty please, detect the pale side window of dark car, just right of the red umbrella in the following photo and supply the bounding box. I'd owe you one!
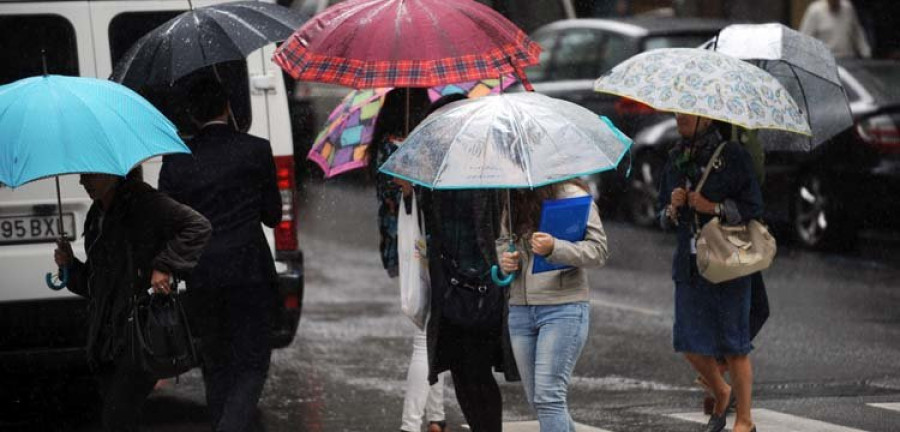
[553,30,604,80]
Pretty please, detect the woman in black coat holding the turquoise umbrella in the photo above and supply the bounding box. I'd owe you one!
[54,170,211,431]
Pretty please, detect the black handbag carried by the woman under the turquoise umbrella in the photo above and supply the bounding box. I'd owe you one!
[131,286,200,379]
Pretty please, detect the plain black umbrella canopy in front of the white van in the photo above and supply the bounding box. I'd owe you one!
[110,1,308,89]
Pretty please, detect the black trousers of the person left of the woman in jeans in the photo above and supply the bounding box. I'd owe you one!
[441,323,503,432]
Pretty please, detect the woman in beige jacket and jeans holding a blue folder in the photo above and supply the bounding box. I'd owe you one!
[497,180,609,432]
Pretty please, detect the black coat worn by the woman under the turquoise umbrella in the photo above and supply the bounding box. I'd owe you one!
[68,180,211,364]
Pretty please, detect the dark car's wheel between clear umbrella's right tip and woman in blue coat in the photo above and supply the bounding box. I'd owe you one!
[624,155,663,226]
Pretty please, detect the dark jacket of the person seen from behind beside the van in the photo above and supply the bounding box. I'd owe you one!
[159,124,281,289]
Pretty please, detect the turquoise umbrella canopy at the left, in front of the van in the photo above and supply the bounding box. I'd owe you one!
[0,75,190,187]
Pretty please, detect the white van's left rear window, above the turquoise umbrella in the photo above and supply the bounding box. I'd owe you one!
[0,14,78,85]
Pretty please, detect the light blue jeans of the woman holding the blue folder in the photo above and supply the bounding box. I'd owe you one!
[509,302,591,432]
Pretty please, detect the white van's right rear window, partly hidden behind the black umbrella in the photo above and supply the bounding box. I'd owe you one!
[109,11,252,135]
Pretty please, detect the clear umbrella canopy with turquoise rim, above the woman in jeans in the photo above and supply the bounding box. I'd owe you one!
[379,92,631,189]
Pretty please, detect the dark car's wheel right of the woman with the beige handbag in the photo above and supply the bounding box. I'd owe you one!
[793,174,856,249]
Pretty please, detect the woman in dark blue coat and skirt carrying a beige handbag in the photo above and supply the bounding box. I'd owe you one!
[659,114,763,432]
